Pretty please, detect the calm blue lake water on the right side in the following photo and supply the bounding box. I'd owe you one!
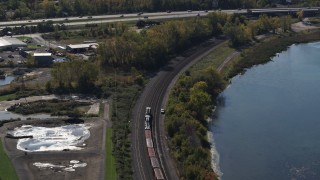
[211,42,320,180]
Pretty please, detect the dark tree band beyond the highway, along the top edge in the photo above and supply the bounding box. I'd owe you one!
[0,0,320,21]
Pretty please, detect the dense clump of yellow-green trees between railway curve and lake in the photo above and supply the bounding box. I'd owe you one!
[165,67,225,179]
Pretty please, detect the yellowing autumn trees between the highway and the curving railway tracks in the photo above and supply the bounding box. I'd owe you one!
[48,13,291,92]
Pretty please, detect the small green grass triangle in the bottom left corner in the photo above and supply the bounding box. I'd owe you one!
[0,140,18,180]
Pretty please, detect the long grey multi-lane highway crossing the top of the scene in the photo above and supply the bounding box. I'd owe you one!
[0,7,319,28]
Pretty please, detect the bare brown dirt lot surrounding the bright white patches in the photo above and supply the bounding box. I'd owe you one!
[0,119,105,180]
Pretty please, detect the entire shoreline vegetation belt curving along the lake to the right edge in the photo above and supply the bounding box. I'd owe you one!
[165,30,320,179]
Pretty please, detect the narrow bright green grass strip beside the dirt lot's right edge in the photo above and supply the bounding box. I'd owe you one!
[105,128,117,180]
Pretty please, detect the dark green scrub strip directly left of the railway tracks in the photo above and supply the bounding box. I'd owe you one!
[111,84,141,179]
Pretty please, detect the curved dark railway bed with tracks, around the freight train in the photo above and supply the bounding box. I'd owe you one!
[132,39,223,180]
